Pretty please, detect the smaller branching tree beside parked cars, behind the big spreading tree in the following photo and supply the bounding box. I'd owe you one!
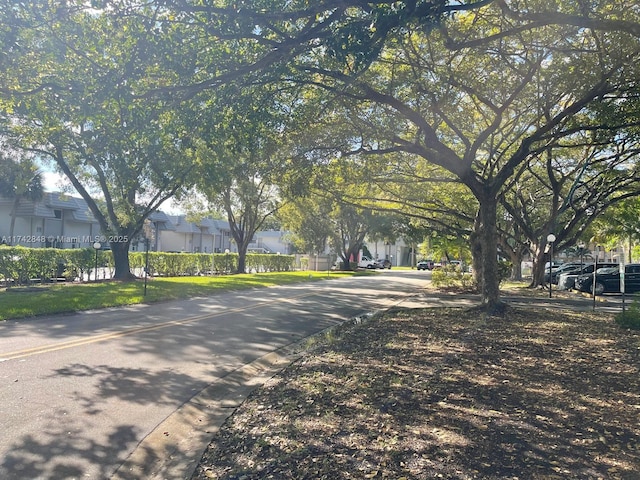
[500,137,640,286]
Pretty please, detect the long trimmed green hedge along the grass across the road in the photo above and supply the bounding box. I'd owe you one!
[0,246,294,285]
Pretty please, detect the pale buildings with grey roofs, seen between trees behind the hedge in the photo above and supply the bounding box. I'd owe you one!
[0,192,411,266]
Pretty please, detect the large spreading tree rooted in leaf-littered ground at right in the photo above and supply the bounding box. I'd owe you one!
[270,1,639,307]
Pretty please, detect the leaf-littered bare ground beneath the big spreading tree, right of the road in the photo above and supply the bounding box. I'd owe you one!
[193,302,640,480]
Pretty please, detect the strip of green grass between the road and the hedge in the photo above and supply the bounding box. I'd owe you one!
[0,271,354,320]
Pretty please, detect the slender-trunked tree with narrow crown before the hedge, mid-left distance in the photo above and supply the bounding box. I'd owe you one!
[193,84,286,273]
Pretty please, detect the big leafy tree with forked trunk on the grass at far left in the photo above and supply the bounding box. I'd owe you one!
[0,2,194,279]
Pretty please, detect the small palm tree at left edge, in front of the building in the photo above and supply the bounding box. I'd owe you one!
[0,155,44,244]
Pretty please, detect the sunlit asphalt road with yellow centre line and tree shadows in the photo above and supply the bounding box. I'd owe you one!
[0,270,430,480]
